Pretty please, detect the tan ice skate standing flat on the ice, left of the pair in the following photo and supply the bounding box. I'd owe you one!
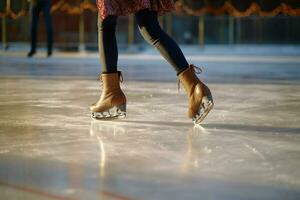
[90,72,126,120]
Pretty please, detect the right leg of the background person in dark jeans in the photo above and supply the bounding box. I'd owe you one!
[43,0,53,56]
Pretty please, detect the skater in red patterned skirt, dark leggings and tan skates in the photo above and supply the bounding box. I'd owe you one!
[90,0,213,124]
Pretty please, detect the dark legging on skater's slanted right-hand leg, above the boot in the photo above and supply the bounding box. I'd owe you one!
[135,10,189,75]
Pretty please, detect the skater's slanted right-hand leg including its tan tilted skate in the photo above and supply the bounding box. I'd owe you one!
[135,10,214,124]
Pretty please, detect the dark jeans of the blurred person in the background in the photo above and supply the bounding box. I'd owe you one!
[28,0,53,56]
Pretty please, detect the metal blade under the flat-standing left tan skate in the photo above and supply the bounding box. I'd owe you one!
[91,105,126,120]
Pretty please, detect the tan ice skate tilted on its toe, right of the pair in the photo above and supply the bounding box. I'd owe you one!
[178,65,214,124]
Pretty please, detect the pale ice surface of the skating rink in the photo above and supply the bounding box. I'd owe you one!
[0,49,300,200]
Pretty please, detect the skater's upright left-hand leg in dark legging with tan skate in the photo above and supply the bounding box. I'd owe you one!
[90,16,126,120]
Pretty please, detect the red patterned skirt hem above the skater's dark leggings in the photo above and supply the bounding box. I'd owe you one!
[97,0,174,19]
